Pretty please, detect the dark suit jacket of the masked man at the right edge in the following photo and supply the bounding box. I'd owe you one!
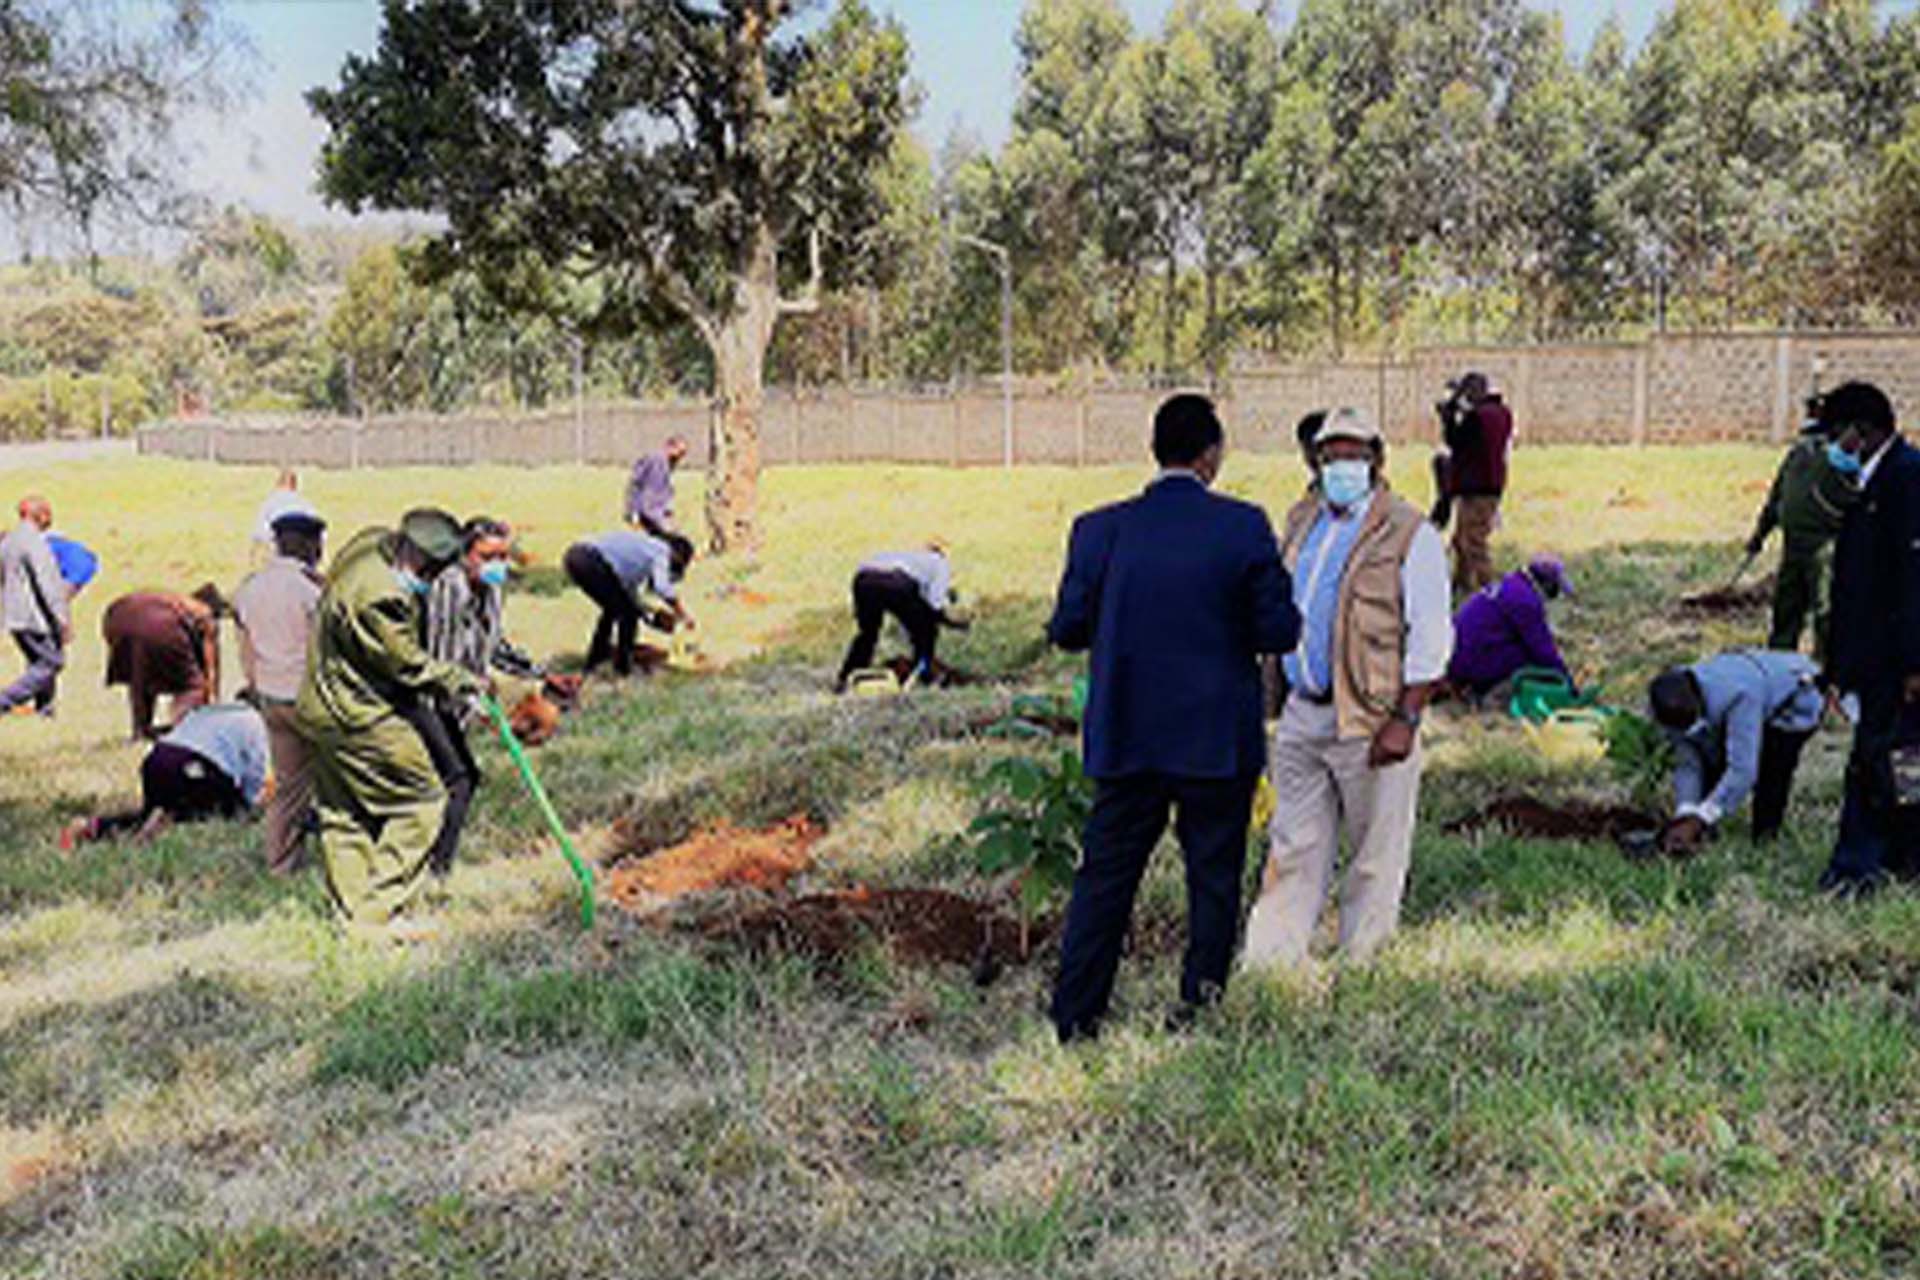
[1826,438,1920,693]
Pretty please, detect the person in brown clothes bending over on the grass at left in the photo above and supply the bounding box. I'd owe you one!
[100,583,227,741]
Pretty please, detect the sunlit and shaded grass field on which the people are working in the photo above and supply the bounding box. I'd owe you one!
[0,447,1920,1280]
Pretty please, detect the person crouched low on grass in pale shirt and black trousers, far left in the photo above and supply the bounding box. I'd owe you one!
[60,702,269,850]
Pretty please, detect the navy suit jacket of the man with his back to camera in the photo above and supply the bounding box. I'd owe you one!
[1046,476,1300,779]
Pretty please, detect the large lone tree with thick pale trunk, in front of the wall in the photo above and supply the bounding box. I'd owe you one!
[309,0,910,549]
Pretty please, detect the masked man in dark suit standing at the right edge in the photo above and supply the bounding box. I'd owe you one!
[1820,382,1920,892]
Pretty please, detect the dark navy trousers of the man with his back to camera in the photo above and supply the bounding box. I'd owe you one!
[1052,773,1258,1040]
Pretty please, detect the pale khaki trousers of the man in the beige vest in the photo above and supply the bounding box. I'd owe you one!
[1242,697,1421,969]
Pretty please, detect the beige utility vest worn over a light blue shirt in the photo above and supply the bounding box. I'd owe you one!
[1281,480,1427,737]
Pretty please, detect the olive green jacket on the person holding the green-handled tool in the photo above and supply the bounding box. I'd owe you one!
[298,530,480,741]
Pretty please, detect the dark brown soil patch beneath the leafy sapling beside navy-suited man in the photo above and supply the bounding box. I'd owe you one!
[699,889,1052,983]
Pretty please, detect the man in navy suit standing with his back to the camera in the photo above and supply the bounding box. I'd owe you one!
[1046,395,1300,1042]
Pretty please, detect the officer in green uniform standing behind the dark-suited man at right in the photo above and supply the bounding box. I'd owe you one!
[1747,397,1859,656]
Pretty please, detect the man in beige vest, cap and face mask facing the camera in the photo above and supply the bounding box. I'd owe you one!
[1246,409,1453,967]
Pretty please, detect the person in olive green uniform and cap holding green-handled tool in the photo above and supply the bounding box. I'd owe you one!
[298,510,480,925]
